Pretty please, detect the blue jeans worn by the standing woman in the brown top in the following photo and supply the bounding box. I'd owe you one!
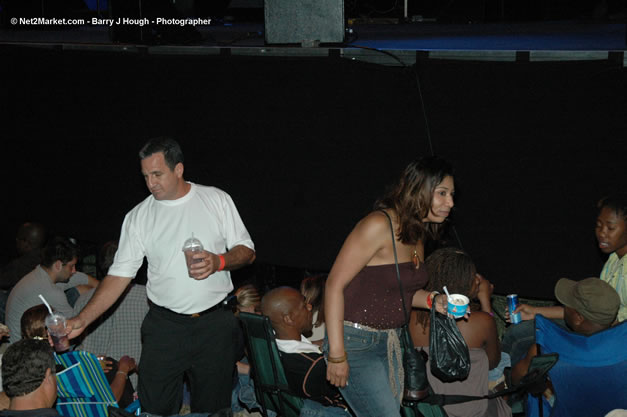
[325,325,403,417]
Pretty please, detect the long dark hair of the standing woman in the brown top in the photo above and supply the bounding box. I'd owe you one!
[374,156,454,245]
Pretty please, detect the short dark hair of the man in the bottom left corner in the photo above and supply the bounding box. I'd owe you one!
[2,339,55,398]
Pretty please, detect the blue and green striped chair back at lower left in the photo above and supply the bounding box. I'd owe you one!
[55,350,118,417]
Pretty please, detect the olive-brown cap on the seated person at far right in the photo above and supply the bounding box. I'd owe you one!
[555,278,620,326]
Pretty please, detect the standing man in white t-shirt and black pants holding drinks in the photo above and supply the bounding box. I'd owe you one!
[68,138,255,416]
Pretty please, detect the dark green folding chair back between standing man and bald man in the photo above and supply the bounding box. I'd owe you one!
[239,312,303,417]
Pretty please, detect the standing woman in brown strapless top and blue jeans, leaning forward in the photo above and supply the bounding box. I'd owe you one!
[325,157,455,417]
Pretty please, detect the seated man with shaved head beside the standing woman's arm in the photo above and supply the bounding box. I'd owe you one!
[261,287,350,417]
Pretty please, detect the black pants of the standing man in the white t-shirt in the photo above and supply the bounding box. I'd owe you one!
[138,305,237,416]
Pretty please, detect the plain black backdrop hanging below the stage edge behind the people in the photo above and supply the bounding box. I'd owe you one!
[0,47,627,297]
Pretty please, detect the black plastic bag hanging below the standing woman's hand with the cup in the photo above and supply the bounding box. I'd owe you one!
[429,308,470,382]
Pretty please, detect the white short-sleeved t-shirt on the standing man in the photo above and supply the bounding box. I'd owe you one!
[109,183,254,314]
